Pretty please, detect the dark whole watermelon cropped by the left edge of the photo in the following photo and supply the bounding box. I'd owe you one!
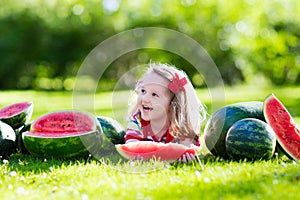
[0,121,16,158]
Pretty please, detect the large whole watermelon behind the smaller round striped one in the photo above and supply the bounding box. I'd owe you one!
[204,101,264,158]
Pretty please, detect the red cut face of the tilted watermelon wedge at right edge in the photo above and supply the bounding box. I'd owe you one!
[264,94,300,160]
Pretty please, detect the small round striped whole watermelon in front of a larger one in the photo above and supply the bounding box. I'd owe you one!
[225,118,276,160]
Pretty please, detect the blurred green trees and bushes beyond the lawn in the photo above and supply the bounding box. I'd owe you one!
[0,0,300,90]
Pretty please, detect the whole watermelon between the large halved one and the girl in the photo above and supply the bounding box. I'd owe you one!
[96,116,125,156]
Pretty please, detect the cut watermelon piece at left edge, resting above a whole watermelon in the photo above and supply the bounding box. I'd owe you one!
[0,102,33,130]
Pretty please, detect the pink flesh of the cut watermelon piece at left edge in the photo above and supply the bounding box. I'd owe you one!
[0,102,32,118]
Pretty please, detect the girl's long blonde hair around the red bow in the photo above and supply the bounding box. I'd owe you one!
[130,62,206,139]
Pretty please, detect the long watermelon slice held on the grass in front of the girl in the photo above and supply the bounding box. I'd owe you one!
[115,141,201,162]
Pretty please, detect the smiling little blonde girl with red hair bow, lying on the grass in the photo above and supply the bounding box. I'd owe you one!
[125,63,206,162]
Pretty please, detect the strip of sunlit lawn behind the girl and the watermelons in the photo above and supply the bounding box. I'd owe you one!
[0,83,300,124]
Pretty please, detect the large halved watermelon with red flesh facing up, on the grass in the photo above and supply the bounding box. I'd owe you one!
[22,110,102,158]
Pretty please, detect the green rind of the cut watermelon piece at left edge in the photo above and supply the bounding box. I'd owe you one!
[0,101,33,130]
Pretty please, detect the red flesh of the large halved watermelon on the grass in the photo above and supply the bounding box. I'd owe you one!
[28,111,96,137]
